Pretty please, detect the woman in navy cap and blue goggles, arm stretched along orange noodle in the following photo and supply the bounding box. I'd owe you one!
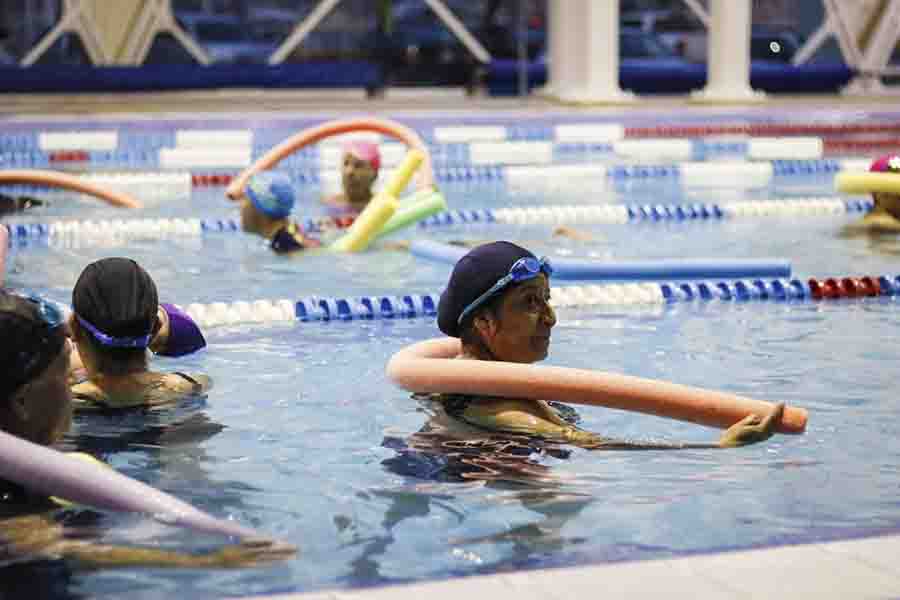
[433,241,784,449]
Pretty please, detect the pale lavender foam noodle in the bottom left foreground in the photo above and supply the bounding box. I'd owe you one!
[0,431,264,539]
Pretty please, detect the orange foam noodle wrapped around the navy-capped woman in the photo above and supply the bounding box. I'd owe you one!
[387,338,807,433]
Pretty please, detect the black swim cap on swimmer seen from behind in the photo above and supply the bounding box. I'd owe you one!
[72,258,159,339]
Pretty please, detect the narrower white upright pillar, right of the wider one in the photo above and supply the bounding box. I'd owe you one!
[692,0,765,103]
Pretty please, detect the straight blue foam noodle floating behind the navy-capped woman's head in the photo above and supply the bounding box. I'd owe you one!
[409,240,791,281]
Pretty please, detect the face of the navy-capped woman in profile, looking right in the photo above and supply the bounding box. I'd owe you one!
[478,273,556,363]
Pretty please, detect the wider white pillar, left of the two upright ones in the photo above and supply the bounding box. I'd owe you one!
[545,0,634,104]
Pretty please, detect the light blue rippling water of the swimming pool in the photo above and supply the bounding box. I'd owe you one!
[3,113,900,598]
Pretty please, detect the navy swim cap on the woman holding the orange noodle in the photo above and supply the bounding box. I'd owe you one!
[438,242,535,337]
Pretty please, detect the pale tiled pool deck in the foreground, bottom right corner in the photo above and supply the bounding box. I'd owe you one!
[256,535,900,600]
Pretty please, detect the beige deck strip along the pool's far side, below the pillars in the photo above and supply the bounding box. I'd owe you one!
[0,88,900,119]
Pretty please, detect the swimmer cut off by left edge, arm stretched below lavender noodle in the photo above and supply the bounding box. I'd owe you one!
[0,291,294,568]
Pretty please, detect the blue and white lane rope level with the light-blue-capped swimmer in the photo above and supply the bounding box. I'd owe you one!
[6,197,872,244]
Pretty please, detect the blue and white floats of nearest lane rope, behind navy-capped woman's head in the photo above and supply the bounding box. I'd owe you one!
[178,276,900,327]
